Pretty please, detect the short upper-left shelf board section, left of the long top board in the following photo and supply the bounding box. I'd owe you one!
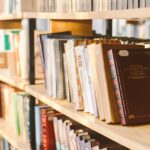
[0,12,23,20]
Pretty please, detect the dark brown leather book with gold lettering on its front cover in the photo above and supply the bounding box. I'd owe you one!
[107,48,150,125]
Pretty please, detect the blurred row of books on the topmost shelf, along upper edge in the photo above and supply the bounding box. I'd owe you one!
[0,0,150,13]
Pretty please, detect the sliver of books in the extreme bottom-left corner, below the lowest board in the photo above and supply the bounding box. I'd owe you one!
[0,137,16,150]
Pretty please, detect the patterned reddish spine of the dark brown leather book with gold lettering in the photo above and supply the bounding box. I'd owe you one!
[107,50,126,125]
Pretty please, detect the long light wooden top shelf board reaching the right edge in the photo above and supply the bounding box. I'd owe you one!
[23,8,150,20]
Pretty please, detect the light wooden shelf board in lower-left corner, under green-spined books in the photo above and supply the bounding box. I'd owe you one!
[0,119,30,150]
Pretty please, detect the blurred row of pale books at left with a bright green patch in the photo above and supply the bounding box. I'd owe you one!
[0,29,28,79]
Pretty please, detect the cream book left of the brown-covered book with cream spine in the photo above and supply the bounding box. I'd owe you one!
[87,44,105,120]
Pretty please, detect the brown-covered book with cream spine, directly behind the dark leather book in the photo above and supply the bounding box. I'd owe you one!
[99,44,144,123]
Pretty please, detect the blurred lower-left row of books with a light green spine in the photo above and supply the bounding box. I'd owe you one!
[0,83,31,146]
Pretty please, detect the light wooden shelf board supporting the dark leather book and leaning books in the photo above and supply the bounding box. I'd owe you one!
[25,85,150,150]
